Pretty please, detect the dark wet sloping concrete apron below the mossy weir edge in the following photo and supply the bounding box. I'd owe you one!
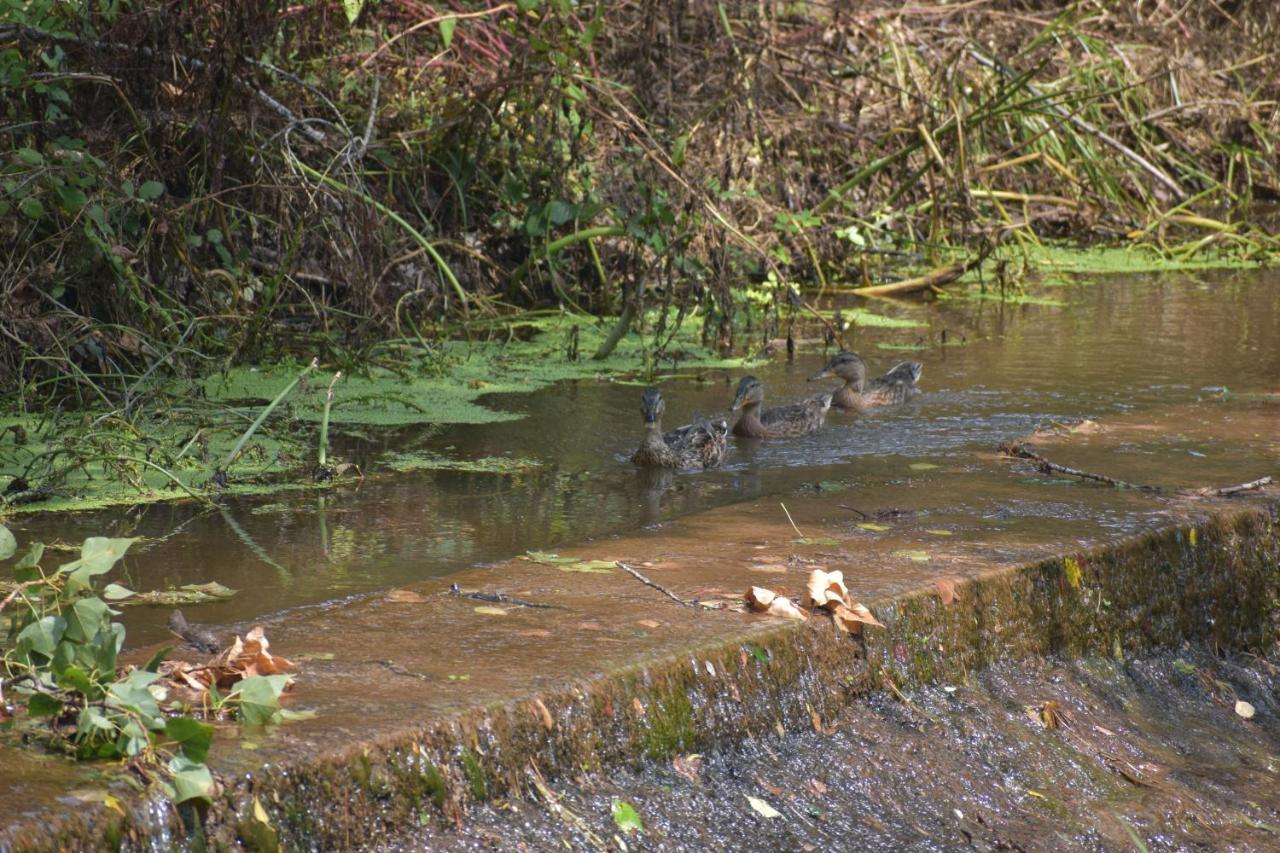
[399,646,1280,850]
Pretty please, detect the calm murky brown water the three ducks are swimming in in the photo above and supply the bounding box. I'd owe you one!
[10,272,1280,646]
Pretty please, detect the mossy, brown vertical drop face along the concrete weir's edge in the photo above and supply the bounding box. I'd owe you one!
[0,500,1280,850]
